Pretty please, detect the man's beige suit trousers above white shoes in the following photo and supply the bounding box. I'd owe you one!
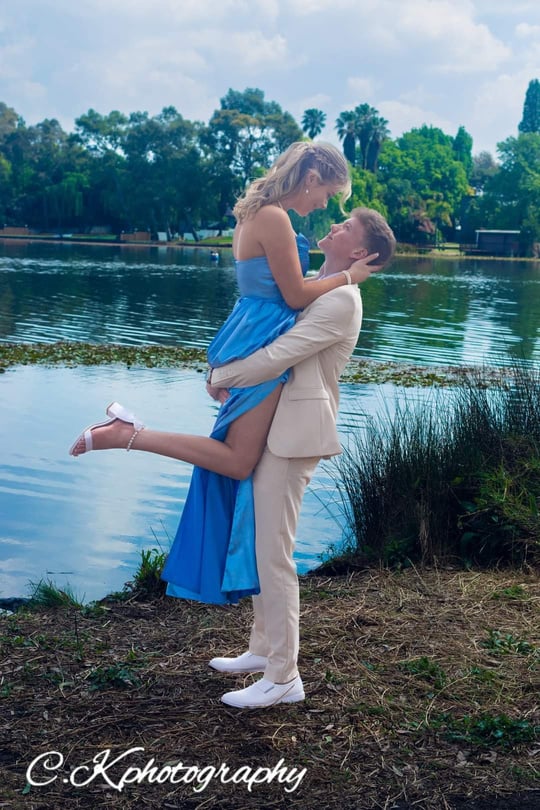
[249,447,319,683]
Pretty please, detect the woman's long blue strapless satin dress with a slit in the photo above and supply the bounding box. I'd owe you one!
[162,234,309,604]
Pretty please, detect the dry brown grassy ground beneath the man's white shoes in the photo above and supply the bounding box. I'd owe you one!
[0,569,540,810]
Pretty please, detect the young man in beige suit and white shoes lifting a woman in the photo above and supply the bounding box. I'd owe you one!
[209,208,395,709]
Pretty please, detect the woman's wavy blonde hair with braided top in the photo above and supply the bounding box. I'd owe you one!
[233,141,351,222]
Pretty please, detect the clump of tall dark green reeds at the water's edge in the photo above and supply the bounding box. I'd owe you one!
[335,364,540,565]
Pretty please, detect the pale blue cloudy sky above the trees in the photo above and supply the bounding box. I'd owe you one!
[0,0,540,157]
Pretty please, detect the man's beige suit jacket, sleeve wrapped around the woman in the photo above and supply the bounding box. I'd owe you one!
[212,286,362,458]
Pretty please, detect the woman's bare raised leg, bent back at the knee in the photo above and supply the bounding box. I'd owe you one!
[83,385,282,479]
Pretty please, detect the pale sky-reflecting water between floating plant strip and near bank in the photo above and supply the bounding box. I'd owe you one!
[0,366,391,600]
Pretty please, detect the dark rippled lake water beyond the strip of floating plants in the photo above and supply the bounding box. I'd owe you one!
[0,243,540,365]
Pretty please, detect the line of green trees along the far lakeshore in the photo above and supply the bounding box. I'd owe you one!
[0,79,540,254]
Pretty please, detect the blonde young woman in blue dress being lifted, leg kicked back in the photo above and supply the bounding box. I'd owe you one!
[70,142,374,603]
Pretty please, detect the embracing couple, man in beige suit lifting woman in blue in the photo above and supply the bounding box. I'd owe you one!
[71,143,395,708]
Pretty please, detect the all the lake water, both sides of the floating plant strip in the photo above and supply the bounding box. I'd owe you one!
[0,242,540,600]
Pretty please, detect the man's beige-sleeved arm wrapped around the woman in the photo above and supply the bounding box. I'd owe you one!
[211,288,362,388]
